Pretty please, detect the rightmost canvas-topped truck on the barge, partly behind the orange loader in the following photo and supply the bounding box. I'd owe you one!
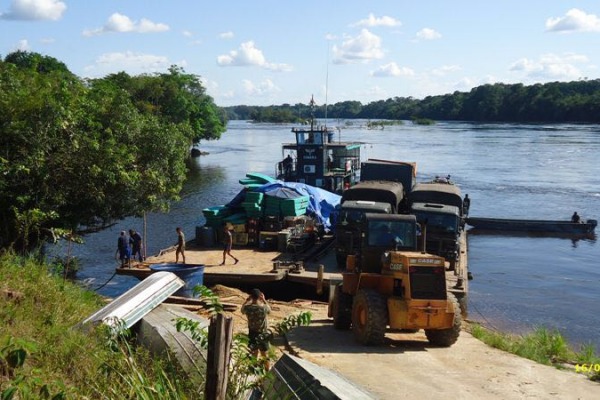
[408,182,464,270]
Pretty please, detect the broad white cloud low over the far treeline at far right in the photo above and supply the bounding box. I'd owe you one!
[509,54,589,81]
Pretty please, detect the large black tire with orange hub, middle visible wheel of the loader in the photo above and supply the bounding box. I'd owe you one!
[352,289,388,345]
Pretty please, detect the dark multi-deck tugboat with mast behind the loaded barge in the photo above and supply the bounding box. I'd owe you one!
[276,97,363,193]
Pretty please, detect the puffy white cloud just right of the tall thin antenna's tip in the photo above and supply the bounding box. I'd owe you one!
[333,29,383,64]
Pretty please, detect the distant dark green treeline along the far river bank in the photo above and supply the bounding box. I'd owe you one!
[226,79,600,123]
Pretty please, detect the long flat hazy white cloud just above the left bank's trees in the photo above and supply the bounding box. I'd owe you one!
[85,51,171,76]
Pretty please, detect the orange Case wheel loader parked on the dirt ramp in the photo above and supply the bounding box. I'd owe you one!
[329,213,462,346]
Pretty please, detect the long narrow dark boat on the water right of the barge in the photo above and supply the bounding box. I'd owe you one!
[465,217,598,235]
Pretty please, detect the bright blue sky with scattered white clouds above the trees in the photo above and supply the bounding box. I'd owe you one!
[0,0,600,106]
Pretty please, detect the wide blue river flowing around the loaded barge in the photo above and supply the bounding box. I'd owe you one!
[61,121,600,350]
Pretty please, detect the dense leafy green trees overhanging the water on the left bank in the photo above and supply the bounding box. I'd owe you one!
[0,51,226,250]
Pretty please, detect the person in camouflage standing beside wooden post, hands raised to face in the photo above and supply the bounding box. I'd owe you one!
[242,289,271,370]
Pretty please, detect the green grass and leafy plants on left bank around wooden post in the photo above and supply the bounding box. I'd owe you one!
[0,253,311,400]
